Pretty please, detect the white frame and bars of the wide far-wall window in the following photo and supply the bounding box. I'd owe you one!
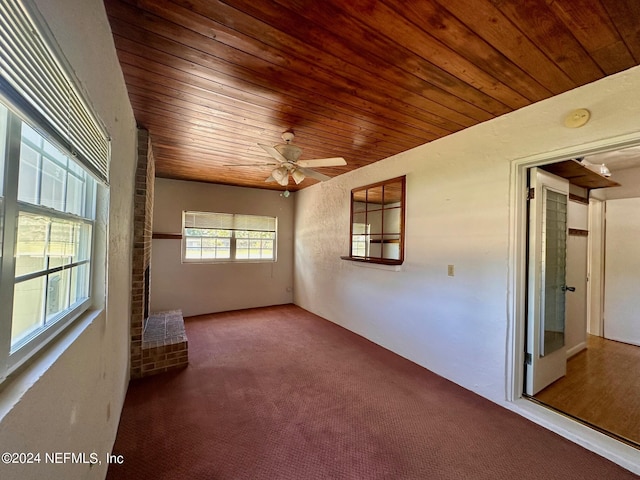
[181,210,278,264]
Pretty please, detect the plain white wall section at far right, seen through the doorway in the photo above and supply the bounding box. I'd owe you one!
[604,198,640,345]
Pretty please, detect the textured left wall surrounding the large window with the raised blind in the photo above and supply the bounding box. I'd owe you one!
[0,0,136,480]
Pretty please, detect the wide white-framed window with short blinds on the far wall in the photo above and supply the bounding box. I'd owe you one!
[182,212,277,263]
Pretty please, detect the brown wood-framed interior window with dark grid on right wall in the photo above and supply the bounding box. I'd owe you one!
[342,177,405,265]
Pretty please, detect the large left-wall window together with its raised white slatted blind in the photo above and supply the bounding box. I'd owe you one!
[0,0,111,381]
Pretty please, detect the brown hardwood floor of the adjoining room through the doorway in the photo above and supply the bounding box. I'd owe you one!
[534,335,640,447]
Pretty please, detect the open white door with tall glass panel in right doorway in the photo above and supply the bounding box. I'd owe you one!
[525,168,569,395]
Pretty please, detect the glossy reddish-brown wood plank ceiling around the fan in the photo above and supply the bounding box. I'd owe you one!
[105,0,640,190]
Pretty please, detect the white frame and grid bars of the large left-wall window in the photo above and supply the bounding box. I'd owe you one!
[0,103,98,383]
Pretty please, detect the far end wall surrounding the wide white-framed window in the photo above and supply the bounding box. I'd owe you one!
[151,178,296,316]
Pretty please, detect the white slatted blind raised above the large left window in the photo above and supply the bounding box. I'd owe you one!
[0,0,110,183]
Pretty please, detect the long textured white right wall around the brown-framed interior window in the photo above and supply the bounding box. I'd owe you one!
[294,68,640,404]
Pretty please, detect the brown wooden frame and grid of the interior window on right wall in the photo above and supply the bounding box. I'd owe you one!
[340,176,406,265]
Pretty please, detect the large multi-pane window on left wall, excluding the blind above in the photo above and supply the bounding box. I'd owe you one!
[0,100,97,373]
